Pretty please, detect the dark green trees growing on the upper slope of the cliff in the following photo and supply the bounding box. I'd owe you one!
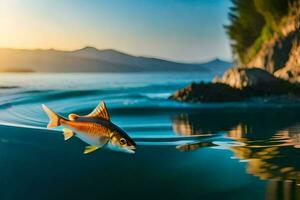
[225,0,297,63]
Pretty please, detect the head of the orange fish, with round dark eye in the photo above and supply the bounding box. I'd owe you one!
[110,131,136,153]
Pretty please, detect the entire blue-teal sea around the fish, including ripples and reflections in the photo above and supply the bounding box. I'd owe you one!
[0,73,300,199]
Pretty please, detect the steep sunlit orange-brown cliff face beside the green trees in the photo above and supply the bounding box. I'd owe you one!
[245,5,300,83]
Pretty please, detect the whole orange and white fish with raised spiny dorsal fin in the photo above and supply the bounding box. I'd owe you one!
[42,101,136,154]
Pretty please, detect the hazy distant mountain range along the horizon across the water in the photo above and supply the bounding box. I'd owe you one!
[0,47,232,72]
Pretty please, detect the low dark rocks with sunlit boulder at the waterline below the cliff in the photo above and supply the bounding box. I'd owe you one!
[170,67,300,102]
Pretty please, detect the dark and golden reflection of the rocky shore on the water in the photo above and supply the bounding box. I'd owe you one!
[172,110,300,199]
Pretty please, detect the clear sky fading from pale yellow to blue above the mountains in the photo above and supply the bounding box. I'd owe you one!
[0,0,231,62]
